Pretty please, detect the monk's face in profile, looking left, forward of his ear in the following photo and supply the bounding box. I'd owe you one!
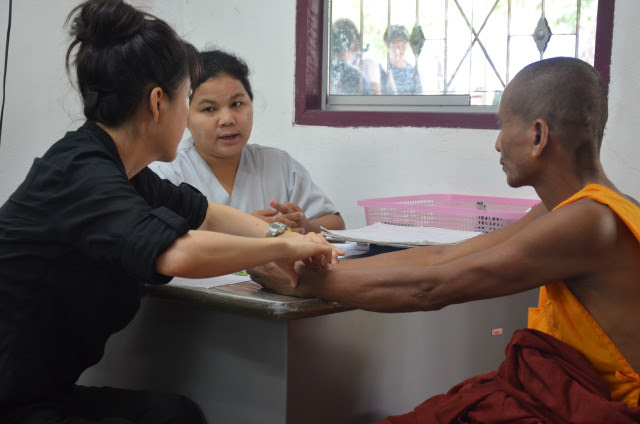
[495,84,531,187]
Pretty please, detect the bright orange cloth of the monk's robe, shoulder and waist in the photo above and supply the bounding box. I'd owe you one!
[528,184,640,407]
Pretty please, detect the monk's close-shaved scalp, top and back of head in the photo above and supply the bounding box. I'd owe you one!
[502,57,608,148]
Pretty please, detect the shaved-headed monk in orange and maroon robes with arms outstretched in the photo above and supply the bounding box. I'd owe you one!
[254,58,640,423]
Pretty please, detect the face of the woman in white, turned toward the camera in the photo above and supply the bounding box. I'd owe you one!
[187,74,253,159]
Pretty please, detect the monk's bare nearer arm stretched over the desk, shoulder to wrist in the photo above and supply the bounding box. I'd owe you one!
[288,201,617,312]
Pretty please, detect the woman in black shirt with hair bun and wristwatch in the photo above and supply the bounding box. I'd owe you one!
[0,0,336,423]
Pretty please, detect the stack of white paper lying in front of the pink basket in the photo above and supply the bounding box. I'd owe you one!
[322,222,482,247]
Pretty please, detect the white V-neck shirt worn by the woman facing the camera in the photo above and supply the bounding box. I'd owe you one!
[149,137,338,219]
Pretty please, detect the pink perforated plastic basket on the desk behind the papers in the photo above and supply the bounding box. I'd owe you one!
[358,194,540,233]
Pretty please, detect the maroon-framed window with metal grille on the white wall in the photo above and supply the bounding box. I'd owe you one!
[296,0,614,128]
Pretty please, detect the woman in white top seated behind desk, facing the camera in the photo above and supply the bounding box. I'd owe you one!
[150,50,344,234]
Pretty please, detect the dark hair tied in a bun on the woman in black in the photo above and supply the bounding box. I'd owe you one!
[65,0,200,126]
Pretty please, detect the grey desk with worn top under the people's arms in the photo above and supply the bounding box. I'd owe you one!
[79,276,537,424]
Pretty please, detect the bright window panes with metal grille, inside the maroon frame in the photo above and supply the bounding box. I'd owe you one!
[330,0,598,107]
